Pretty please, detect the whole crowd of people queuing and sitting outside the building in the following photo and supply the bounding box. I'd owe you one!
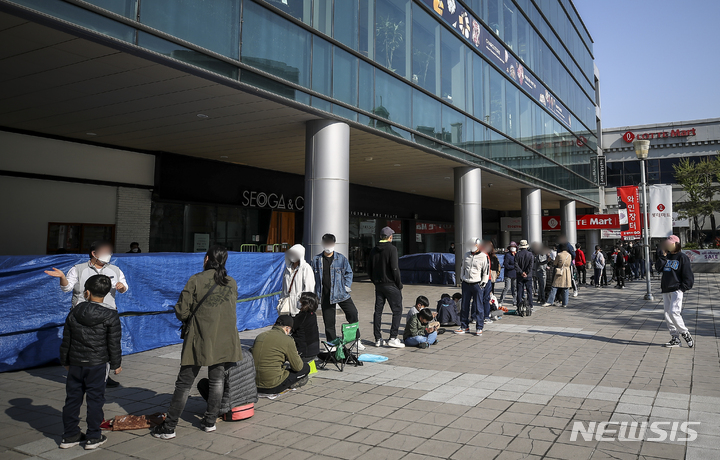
[46,227,694,450]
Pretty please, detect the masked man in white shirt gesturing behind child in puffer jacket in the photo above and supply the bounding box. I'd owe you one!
[45,241,129,388]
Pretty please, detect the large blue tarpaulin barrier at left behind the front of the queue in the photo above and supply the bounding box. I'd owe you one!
[0,252,284,372]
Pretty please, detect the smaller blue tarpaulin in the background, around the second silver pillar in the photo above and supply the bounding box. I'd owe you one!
[399,252,505,286]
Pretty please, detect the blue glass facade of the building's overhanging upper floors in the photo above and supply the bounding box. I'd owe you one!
[11,0,597,205]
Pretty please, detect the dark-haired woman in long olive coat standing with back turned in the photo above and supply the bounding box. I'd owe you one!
[152,245,242,440]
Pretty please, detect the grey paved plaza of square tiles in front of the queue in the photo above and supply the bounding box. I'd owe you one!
[0,274,720,460]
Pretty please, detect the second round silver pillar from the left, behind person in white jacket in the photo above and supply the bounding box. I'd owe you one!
[454,166,482,283]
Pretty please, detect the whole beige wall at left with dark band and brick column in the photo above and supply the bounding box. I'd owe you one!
[0,131,155,255]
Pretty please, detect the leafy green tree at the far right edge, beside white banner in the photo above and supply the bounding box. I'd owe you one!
[673,157,720,245]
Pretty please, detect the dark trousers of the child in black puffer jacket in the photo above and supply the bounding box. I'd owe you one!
[62,364,108,439]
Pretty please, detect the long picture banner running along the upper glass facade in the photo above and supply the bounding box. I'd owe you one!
[424,0,572,129]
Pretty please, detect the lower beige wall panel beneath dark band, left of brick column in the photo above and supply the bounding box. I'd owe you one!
[0,176,117,255]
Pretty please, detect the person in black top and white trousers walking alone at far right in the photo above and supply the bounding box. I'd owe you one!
[655,235,695,348]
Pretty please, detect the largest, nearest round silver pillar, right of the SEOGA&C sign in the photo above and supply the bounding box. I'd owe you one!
[303,120,350,260]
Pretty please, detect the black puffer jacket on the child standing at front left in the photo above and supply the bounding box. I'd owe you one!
[60,302,122,369]
